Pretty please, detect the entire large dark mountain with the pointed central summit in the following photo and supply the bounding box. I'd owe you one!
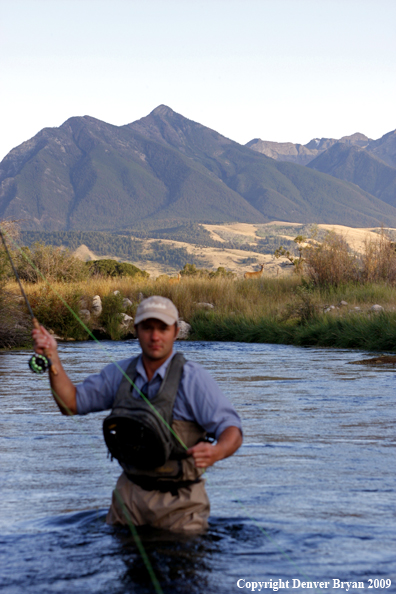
[0,105,396,231]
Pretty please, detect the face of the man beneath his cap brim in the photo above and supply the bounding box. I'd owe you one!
[136,318,179,361]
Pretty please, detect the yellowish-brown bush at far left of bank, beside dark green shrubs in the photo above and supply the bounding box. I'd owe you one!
[16,243,89,283]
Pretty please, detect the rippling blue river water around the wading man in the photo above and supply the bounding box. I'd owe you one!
[0,340,396,594]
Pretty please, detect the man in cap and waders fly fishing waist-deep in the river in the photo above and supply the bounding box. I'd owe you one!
[33,296,242,533]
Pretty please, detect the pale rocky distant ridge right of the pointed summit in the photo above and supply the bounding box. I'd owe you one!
[245,132,370,165]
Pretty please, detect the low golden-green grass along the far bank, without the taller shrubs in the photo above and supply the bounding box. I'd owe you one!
[7,275,396,351]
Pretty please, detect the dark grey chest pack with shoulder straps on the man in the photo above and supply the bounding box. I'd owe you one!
[103,353,186,470]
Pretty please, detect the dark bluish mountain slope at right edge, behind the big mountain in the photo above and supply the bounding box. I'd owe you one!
[307,142,396,207]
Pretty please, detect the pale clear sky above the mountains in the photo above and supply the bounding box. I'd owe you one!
[0,0,396,159]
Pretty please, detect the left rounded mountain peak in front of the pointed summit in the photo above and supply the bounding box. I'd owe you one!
[0,111,265,231]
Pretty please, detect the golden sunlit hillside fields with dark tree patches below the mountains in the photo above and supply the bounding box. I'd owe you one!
[22,221,396,278]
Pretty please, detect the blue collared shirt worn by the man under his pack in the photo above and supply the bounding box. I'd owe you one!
[77,346,242,439]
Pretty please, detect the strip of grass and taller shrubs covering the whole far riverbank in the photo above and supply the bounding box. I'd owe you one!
[0,224,396,351]
